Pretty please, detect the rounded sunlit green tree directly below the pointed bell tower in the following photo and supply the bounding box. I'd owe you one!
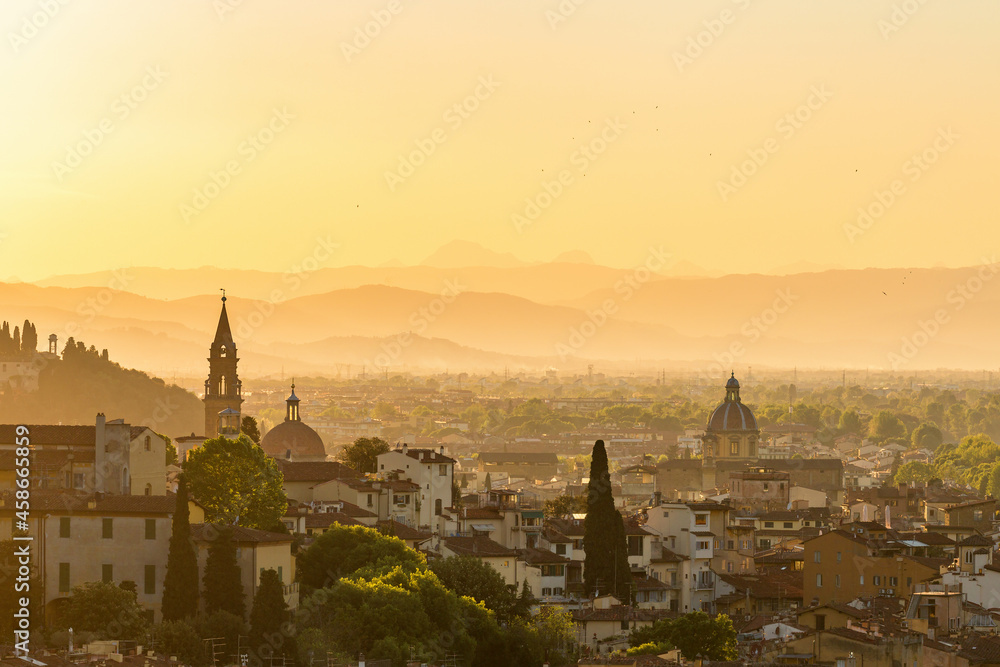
[184,435,288,530]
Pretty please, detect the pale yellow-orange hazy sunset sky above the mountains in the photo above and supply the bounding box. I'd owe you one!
[0,0,1000,280]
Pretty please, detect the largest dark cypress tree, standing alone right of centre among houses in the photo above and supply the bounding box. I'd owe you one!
[583,440,632,604]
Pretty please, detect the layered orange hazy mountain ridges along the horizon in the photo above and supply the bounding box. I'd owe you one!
[11,256,1000,376]
